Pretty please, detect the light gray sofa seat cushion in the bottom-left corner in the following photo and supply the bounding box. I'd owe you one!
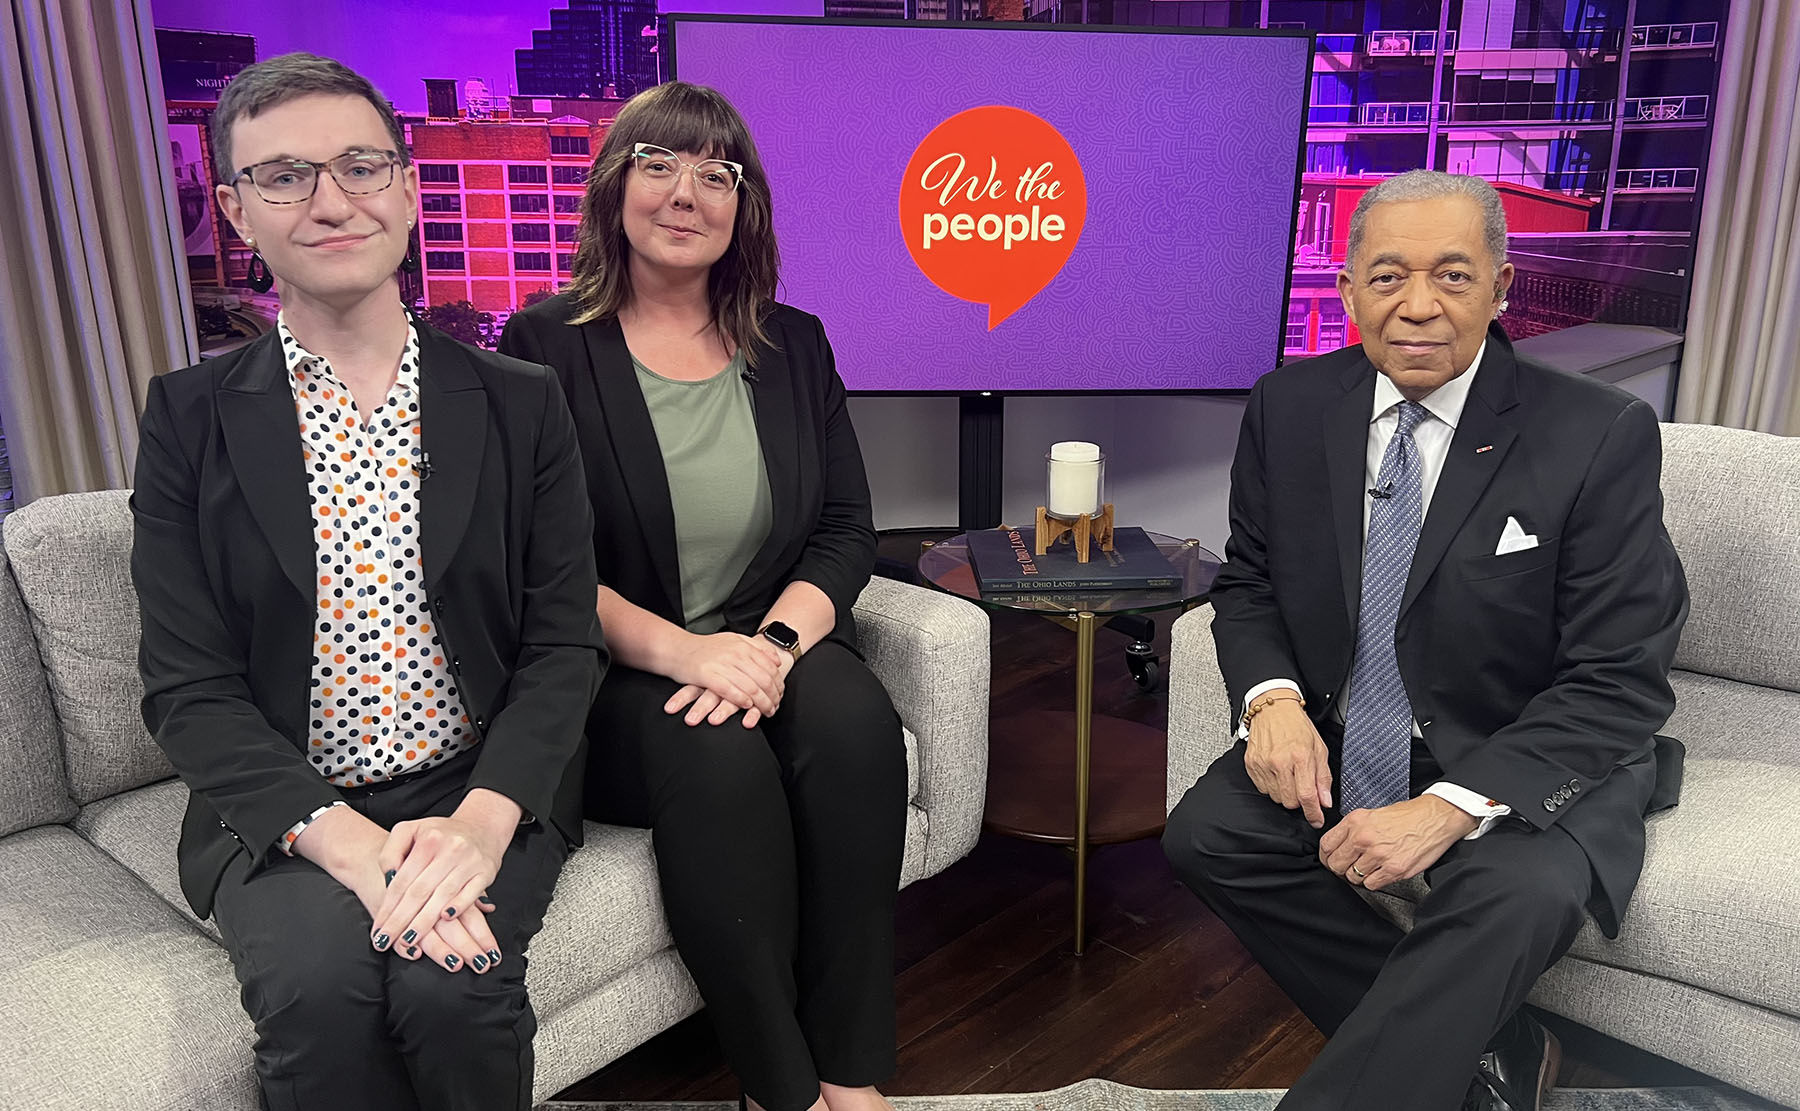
[0,826,257,1111]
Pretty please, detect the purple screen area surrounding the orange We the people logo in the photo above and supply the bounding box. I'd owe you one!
[675,18,1309,393]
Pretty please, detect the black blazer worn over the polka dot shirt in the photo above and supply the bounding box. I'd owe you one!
[131,322,607,917]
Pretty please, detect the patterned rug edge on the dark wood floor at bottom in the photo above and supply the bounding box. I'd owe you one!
[540,1080,1777,1111]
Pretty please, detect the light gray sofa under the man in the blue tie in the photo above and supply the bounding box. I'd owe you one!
[1168,425,1800,1106]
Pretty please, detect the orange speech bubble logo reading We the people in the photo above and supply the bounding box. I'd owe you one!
[900,104,1087,331]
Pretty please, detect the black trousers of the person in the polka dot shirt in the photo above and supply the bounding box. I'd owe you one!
[212,753,569,1111]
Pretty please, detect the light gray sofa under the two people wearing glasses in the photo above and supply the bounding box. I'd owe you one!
[0,492,988,1111]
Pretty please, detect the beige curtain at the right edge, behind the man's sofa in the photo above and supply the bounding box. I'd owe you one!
[1676,0,1800,436]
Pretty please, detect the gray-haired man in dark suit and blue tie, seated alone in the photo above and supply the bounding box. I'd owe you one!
[1163,171,1687,1111]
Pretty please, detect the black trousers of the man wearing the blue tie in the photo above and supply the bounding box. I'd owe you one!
[1163,744,1593,1111]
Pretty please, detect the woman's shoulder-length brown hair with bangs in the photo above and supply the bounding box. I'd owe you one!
[569,81,781,366]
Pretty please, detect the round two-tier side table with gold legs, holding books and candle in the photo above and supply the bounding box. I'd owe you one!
[918,533,1219,954]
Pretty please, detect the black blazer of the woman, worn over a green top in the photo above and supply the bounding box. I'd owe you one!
[500,295,875,650]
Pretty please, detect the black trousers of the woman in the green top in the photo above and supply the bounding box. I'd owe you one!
[587,641,905,1111]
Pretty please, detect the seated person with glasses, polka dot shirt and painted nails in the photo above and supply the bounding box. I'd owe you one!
[131,54,608,1111]
